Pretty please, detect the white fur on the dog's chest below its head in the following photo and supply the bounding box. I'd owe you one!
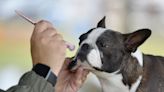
[93,71,142,92]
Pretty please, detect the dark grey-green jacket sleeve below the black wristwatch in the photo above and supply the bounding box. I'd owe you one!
[0,71,54,92]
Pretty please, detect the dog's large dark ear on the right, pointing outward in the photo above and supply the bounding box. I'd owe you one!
[124,29,151,52]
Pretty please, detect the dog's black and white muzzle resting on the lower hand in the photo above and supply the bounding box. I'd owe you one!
[68,49,103,71]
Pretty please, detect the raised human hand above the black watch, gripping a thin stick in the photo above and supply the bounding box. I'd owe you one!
[31,20,66,75]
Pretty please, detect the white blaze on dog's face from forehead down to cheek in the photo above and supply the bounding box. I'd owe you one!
[80,28,106,69]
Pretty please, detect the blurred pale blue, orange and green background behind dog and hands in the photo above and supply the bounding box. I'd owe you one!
[0,0,164,92]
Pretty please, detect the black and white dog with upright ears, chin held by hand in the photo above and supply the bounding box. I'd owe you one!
[70,17,164,92]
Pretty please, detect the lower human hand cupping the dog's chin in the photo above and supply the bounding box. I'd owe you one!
[55,59,89,92]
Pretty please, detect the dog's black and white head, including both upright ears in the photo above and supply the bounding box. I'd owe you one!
[69,17,151,73]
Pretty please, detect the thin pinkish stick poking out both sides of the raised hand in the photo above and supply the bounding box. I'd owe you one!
[15,10,75,51]
